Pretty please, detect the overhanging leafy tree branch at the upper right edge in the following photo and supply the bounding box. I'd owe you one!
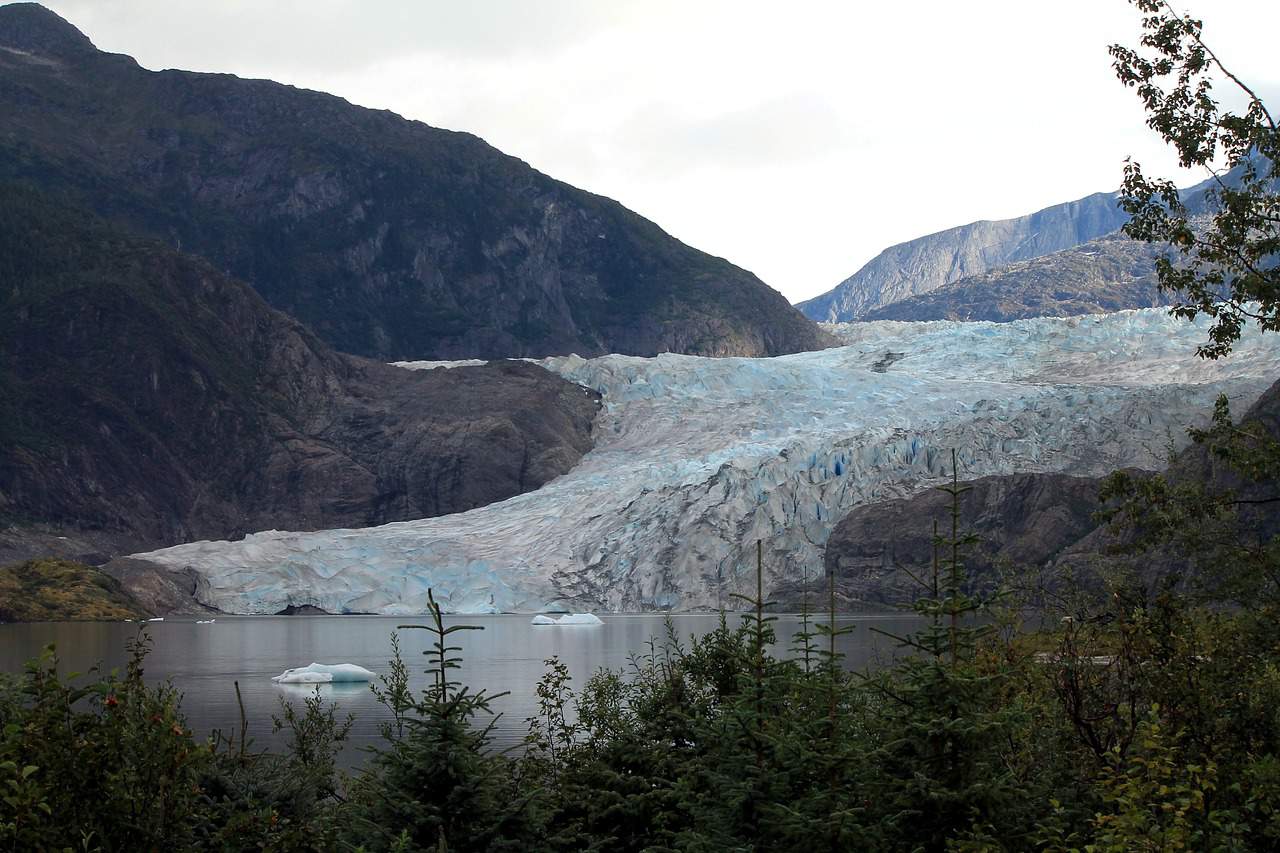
[1110,0,1280,359]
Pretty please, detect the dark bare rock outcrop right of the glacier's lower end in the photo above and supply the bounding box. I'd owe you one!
[819,382,1280,605]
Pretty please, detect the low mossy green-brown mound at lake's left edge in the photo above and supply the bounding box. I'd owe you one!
[0,560,147,622]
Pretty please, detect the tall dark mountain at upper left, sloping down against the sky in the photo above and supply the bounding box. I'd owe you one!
[0,4,829,360]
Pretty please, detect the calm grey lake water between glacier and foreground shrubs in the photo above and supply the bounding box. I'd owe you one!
[0,613,920,766]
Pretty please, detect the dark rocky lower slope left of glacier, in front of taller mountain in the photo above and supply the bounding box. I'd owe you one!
[0,184,599,562]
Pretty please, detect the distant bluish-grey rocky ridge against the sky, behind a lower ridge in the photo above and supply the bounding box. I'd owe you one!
[796,192,1129,323]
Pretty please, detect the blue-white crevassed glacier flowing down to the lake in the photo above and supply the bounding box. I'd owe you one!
[124,309,1280,615]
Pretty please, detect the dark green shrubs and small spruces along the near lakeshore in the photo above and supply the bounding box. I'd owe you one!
[0,588,1280,850]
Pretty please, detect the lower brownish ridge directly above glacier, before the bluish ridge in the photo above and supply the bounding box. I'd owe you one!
[861,233,1170,323]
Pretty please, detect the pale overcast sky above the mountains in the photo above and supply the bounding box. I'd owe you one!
[20,0,1280,301]
